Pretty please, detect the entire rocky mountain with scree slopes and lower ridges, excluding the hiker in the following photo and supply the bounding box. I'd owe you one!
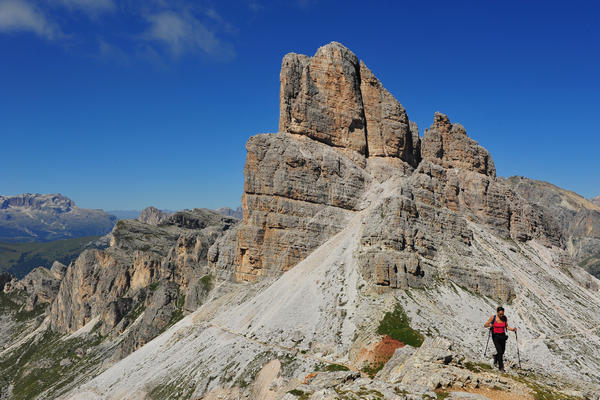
[0,42,600,400]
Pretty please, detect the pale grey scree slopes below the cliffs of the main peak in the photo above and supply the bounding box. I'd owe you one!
[64,177,600,399]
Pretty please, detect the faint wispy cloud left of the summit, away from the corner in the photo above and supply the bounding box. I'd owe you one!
[145,11,234,59]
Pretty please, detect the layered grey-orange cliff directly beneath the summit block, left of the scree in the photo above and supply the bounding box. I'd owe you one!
[209,132,370,281]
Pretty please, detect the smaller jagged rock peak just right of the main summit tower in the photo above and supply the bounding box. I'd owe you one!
[421,112,496,177]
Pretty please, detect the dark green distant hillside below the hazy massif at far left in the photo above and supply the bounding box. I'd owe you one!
[0,236,100,278]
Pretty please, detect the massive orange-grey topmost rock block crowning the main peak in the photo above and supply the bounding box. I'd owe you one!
[279,42,419,166]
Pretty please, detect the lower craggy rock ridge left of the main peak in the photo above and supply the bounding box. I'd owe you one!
[50,209,236,355]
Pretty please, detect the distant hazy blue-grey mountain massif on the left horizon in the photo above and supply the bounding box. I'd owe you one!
[0,193,116,242]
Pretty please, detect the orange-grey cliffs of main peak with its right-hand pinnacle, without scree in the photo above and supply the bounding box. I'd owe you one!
[209,42,563,292]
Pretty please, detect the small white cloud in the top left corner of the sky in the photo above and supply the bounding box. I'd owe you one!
[0,0,60,39]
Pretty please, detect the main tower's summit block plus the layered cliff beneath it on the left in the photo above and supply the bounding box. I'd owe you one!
[209,42,420,281]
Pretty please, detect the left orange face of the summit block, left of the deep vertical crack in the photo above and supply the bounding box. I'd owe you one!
[279,43,367,155]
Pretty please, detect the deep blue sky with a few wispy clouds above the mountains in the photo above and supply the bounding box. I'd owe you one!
[0,0,600,210]
